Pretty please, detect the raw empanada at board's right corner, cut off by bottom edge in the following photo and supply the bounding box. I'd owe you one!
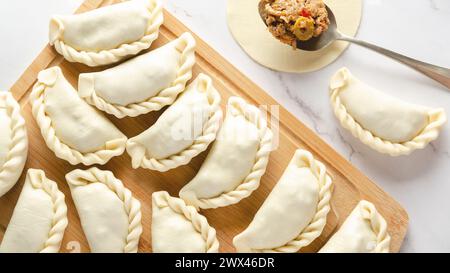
[319,200,391,253]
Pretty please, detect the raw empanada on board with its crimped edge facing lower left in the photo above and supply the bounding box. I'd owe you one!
[30,67,127,165]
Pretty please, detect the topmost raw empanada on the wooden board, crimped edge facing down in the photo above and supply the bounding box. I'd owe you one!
[49,0,163,66]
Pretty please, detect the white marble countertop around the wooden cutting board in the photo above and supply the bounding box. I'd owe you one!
[0,0,450,252]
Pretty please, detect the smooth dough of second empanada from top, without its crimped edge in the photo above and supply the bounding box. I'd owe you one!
[78,40,182,106]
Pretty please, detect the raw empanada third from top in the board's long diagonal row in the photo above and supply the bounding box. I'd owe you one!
[127,74,222,172]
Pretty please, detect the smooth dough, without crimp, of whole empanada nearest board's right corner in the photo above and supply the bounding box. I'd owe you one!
[233,163,320,252]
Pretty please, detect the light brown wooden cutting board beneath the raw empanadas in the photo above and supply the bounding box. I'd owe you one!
[0,0,408,252]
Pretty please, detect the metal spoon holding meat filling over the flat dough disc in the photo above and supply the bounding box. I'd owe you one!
[258,1,450,89]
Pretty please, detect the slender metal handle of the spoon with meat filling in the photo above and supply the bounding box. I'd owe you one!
[336,34,450,89]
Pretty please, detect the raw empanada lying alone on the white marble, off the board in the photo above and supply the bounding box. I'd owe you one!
[330,68,447,156]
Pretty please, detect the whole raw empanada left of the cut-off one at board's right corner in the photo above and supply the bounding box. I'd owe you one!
[233,149,332,252]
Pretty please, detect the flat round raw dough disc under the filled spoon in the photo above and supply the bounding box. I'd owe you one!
[227,0,362,73]
